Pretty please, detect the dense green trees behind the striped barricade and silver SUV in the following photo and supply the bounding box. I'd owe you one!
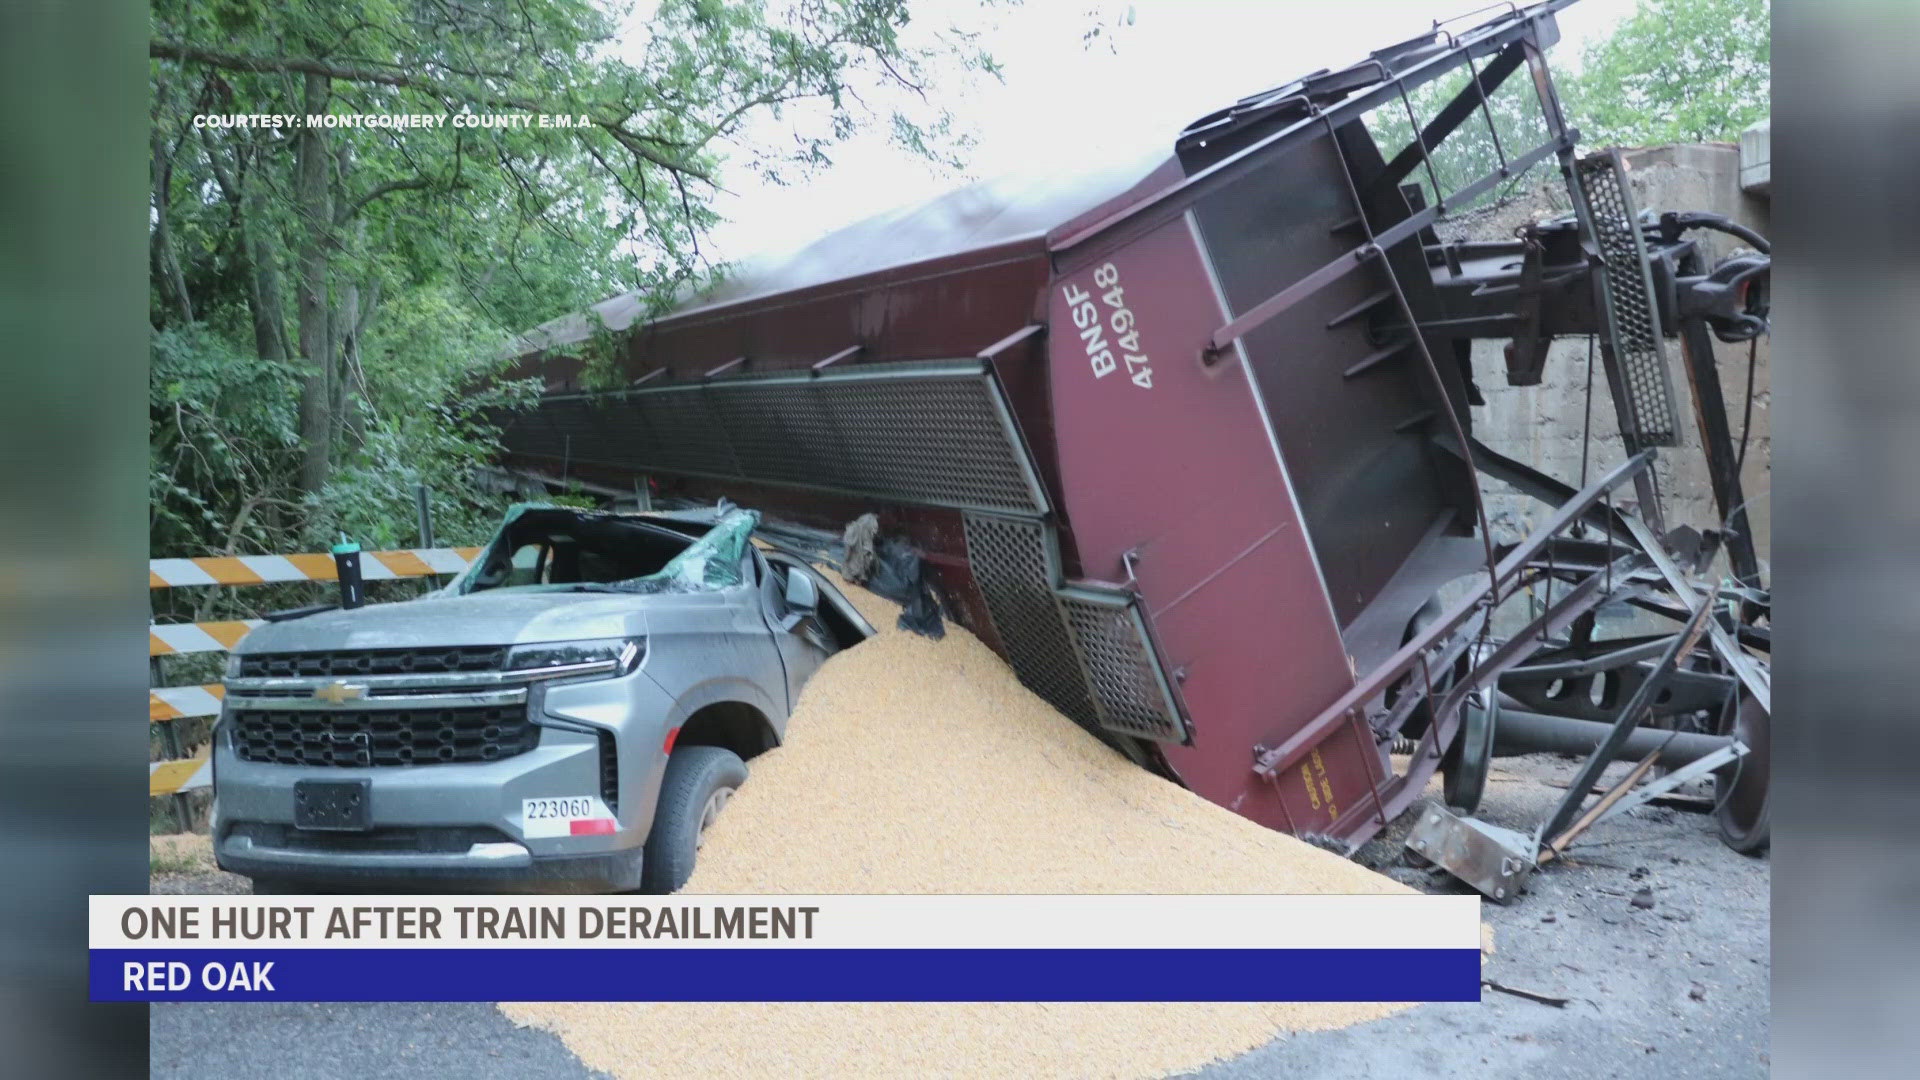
[148,0,993,553]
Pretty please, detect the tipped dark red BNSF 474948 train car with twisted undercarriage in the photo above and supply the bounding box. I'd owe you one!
[505,0,1766,849]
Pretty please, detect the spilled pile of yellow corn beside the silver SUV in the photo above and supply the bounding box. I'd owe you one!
[501,588,1409,1080]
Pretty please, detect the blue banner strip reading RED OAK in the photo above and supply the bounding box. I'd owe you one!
[88,947,1480,1001]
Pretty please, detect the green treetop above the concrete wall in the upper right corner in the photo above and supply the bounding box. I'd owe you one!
[1561,0,1772,146]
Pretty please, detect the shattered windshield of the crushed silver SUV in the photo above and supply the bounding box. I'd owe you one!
[453,505,760,594]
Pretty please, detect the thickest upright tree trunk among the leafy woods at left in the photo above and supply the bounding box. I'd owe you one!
[294,73,334,494]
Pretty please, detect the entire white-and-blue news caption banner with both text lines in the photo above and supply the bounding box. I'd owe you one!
[88,896,1480,1001]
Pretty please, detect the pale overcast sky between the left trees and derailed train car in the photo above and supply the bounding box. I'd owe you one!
[625,0,1634,259]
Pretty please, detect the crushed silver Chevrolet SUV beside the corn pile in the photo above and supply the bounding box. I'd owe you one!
[213,505,872,892]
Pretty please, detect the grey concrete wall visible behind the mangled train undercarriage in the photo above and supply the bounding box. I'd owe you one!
[1440,144,1772,571]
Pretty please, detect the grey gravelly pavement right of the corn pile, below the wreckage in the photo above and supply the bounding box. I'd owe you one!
[1194,755,1770,1080]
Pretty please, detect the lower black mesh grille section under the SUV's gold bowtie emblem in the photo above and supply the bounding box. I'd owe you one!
[228,703,540,767]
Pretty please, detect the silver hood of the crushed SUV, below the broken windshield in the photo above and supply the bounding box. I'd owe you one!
[234,592,657,653]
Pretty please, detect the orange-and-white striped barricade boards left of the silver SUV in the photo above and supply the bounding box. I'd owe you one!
[146,548,480,818]
